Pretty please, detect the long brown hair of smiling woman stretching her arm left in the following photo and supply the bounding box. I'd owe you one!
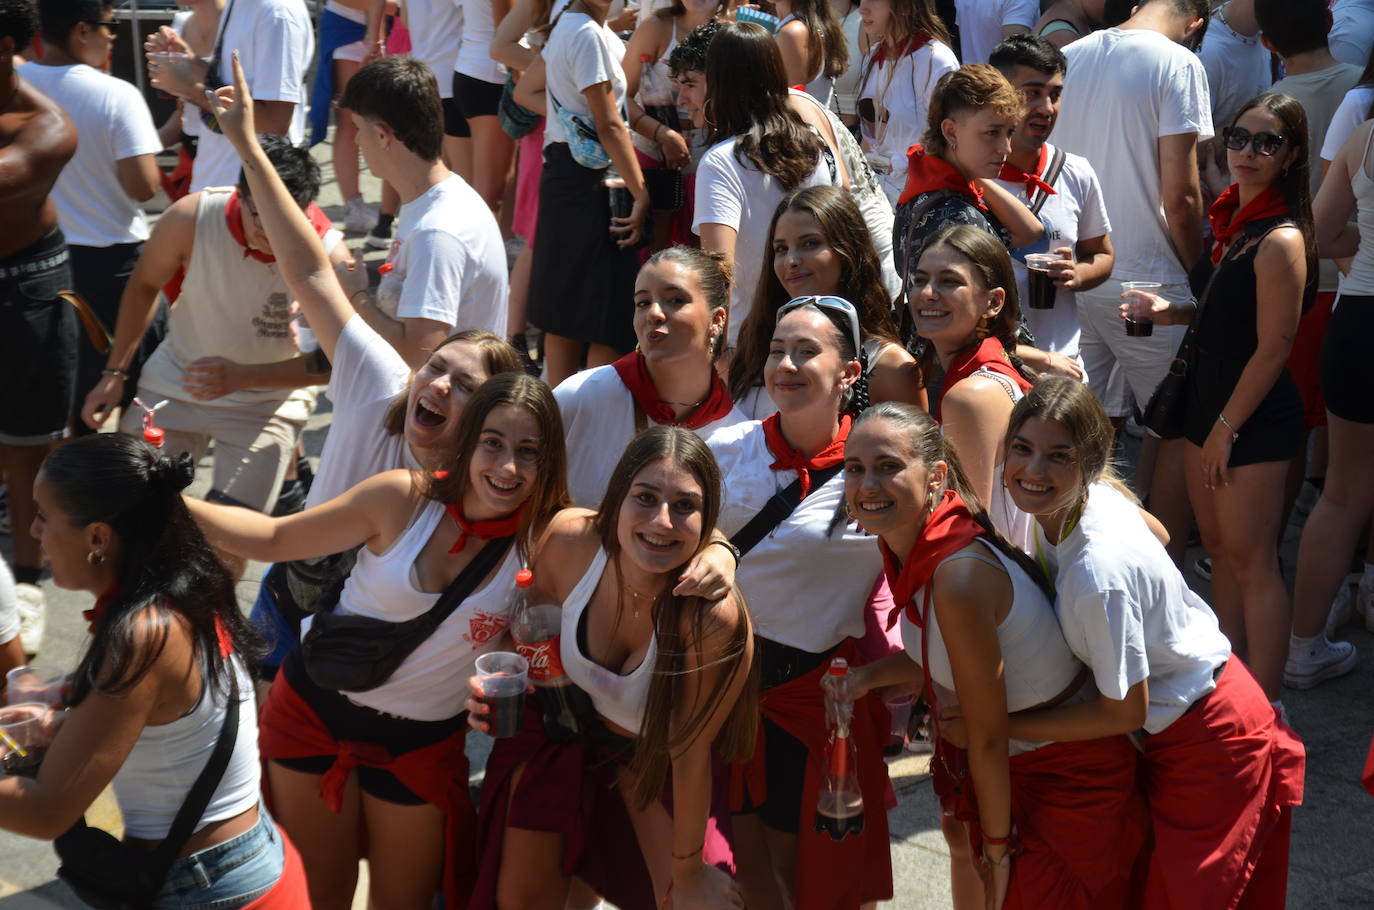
[420,373,570,561]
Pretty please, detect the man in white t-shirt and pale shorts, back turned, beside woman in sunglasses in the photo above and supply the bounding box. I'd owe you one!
[1055,0,1212,555]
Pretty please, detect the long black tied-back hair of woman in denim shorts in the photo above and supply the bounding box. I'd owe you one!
[40,433,260,707]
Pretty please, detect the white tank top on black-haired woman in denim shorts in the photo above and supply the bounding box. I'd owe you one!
[113,656,262,840]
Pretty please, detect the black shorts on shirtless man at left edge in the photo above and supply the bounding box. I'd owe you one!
[0,228,80,445]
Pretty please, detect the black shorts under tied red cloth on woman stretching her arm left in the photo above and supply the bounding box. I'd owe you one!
[272,647,467,806]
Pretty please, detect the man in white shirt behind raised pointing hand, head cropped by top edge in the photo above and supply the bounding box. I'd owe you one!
[147,0,315,192]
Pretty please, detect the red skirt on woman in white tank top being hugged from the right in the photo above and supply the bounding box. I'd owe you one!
[930,737,1149,910]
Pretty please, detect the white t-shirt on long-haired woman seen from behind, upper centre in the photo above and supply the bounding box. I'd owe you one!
[691,139,831,345]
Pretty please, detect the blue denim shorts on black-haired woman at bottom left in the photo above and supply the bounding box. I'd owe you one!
[153,806,286,910]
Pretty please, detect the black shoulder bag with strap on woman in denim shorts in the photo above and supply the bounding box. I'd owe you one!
[52,673,239,910]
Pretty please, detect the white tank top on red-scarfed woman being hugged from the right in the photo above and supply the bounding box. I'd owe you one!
[901,537,1083,751]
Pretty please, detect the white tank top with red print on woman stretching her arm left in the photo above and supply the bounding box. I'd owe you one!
[327,499,521,720]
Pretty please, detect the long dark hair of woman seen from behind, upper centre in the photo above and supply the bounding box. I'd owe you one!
[703,22,822,190]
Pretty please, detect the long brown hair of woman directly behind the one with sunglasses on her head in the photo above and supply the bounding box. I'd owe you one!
[730,187,900,401]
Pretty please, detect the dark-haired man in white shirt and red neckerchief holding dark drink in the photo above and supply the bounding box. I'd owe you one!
[989,34,1114,382]
